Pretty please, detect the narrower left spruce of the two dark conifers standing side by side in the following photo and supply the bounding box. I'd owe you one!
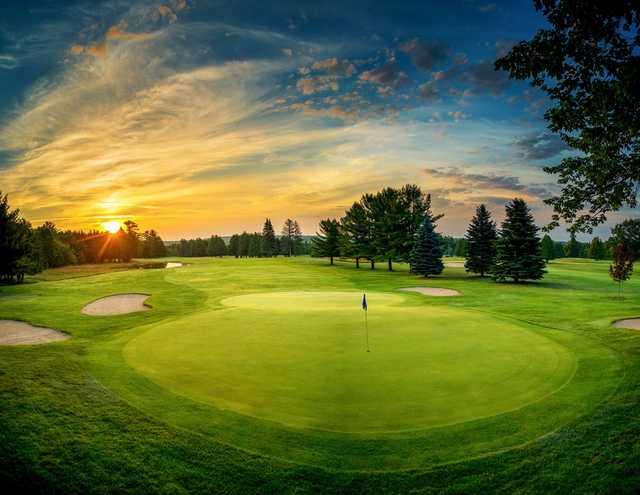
[464,205,497,277]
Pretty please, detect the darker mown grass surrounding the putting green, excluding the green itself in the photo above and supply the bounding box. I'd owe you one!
[0,259,640,493]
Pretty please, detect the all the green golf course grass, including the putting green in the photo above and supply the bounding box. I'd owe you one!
[0,258,640,493]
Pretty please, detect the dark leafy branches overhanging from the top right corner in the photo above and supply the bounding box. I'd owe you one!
[495,0,640,232]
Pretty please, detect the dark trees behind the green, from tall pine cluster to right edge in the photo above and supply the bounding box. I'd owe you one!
[312,184,640,282]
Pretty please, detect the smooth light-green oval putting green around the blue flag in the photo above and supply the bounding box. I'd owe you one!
[123,291,577,434]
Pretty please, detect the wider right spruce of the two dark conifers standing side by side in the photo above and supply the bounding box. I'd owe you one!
[492,198,545,283]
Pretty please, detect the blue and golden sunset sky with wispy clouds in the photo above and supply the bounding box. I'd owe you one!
[0,0,620,240]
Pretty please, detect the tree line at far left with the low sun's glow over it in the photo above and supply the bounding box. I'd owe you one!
[0,193,167,282]
